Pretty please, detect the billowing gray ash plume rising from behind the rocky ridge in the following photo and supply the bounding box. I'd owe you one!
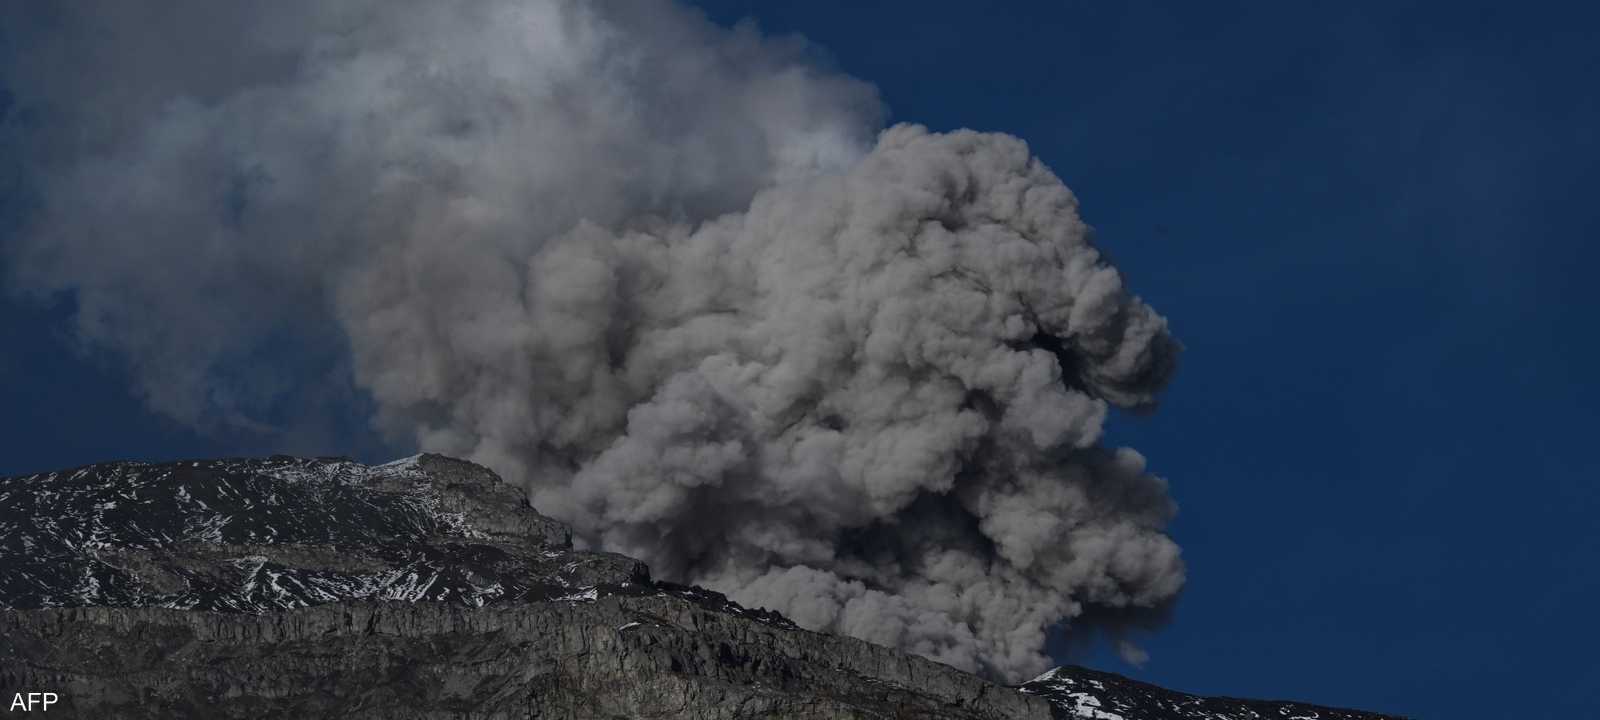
[5,0,1184,678]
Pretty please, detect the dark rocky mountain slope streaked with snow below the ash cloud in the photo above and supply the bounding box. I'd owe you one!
[0,456,1401,720]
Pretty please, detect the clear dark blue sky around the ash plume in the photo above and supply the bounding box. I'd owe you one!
[0,0,1600,718]
